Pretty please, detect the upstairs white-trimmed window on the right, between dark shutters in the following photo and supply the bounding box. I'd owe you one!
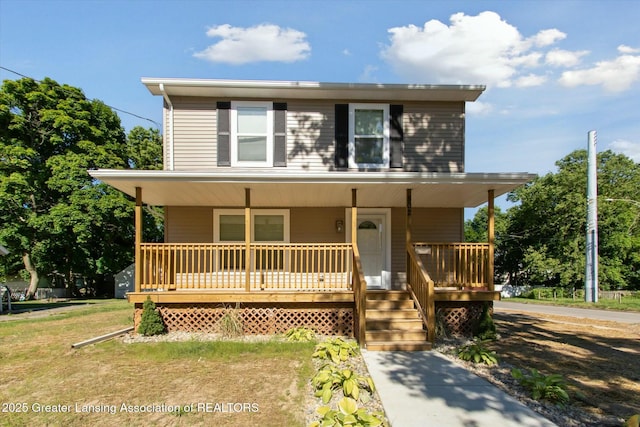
[349,104,389,168]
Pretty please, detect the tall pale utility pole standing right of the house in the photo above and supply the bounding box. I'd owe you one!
[584,130,598,302]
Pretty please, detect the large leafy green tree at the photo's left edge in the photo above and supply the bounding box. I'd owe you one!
[0,78,132,297]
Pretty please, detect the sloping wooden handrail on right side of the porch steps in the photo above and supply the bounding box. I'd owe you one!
[407,243,436,342]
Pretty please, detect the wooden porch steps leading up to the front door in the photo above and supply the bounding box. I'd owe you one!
[365,291,431,351]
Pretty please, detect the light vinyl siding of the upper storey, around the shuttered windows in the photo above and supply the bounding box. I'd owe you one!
[164,97,465,172]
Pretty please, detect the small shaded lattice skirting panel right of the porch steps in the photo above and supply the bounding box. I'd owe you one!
[436,301,493,336]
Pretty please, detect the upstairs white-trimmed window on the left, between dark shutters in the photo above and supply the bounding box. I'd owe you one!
[230,101,273,167]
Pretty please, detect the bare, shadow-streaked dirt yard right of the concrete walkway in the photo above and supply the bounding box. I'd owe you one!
[490,311,640,425]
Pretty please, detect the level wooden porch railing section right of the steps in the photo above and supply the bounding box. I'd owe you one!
[414,243,493,290]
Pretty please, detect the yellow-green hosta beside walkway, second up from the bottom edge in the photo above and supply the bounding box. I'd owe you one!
[311,365,375,403]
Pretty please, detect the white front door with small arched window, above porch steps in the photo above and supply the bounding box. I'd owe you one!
[358,215,387,289]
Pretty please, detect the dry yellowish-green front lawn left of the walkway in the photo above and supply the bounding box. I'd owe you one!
[0,300,313,426]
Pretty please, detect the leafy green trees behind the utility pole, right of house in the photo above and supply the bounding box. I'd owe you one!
[500,150,640,289]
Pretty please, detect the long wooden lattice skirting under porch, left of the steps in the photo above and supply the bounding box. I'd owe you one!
[134,303,353,337]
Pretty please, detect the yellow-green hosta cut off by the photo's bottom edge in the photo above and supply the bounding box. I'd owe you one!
[310,397,387,427]
